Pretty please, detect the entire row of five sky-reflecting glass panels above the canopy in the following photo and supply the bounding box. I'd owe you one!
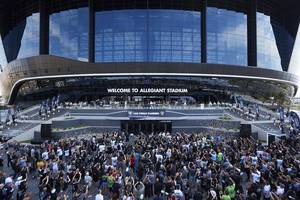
[0,4,299,74]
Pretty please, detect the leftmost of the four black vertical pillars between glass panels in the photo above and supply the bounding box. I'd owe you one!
[39,0,49,54]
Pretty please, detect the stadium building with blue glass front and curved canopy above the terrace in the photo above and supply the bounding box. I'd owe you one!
[0,0,300,136]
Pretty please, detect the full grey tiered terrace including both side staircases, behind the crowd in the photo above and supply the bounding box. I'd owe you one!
[6,107,282,141]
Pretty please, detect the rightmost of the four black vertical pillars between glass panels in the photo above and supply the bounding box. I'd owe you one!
[247,0,257,66]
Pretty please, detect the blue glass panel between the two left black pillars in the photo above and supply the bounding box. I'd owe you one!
[49,8,89,61]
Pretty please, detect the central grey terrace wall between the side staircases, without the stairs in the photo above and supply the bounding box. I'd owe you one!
[52,108,239,133]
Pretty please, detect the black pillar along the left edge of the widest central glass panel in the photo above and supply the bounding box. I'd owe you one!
[89,0,95,62]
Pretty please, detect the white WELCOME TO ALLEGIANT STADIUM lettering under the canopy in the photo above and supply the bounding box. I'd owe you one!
[107,88,189,94]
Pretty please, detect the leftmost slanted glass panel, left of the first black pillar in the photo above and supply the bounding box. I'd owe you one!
[0,13,40,62]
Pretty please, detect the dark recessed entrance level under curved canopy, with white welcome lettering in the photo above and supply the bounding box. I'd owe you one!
[11,75,295,111]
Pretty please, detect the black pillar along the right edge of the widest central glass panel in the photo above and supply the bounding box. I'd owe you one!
[201,0,207,63]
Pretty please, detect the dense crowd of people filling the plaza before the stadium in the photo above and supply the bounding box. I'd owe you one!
[0,132,300,200]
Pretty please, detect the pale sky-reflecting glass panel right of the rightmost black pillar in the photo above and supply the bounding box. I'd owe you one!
[257,13,282,71]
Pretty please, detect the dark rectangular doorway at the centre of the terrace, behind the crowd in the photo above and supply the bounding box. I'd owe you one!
[121,120,172,134]
